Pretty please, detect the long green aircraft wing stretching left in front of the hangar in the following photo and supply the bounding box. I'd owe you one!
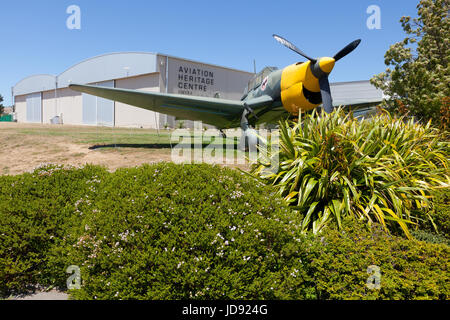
[69,84,273,129]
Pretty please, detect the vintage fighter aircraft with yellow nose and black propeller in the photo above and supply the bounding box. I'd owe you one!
[69,35,361,146]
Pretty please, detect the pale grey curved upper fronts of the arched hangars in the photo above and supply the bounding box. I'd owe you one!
[13,52,157,96]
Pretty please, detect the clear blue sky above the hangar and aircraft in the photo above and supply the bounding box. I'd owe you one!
[0,0,418,105]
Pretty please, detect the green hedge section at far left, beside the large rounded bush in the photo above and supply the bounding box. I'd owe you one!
[0,165,107,295]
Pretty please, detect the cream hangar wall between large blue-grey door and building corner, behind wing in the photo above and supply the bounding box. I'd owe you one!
[115,73,160,129]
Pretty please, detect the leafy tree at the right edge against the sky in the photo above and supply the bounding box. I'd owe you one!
[371,0,450,129]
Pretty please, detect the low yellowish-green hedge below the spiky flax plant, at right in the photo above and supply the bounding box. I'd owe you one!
[281,218,450,300]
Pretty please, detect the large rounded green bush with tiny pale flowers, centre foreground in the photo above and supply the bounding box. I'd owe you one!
[52,164,293,299]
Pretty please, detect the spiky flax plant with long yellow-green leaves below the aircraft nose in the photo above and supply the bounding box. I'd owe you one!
[251,109,450,238]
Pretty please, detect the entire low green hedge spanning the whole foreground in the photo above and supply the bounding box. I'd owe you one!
[0,163,449,299]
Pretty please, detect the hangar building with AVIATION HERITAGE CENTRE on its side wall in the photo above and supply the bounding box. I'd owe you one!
[12,52,382,129]
